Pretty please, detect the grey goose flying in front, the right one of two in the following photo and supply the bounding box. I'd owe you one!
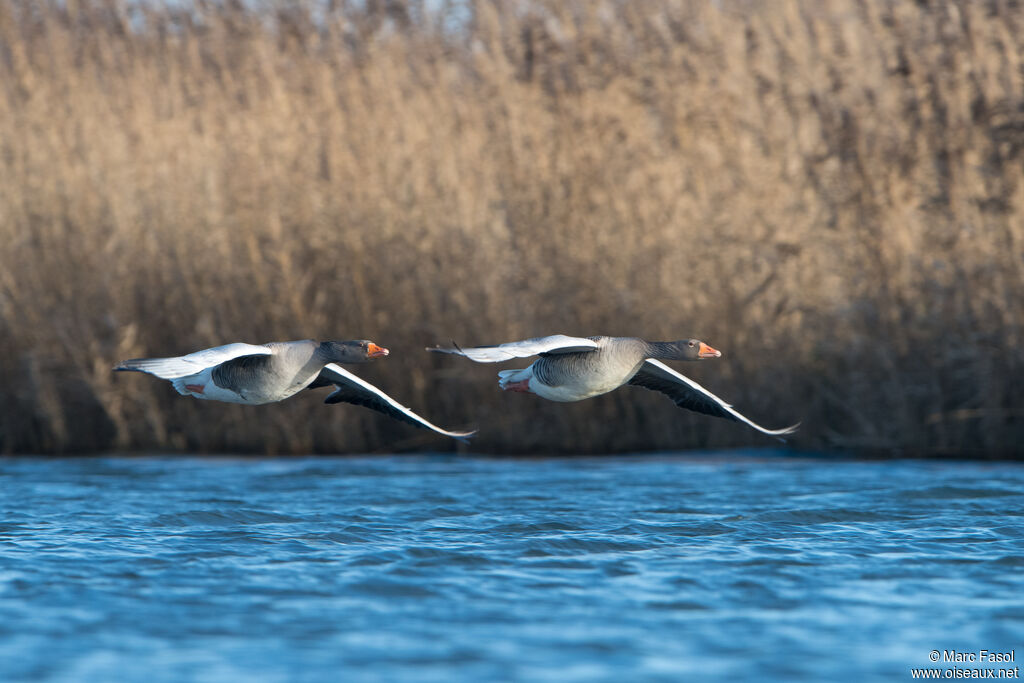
[427,335,800,440]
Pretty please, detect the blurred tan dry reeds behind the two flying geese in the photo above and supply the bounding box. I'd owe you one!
[0,0,1024,454]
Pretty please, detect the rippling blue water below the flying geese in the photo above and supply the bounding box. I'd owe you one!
[0,453,1024,683]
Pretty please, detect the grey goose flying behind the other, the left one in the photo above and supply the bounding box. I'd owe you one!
[114,339,476,440]
